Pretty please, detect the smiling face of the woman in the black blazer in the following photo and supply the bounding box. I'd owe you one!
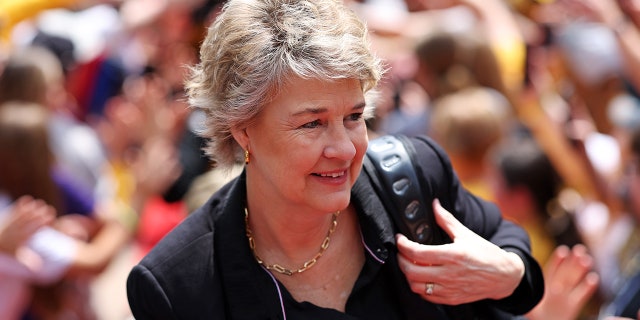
[243,78,368,212]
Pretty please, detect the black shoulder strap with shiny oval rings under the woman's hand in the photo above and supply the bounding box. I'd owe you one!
[364,135,441,244]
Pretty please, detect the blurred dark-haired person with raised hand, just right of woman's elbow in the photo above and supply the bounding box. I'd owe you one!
[492,134,602,320]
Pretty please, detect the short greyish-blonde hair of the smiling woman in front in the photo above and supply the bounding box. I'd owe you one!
[186,0,383,168]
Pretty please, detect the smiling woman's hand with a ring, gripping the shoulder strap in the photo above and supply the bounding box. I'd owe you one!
[397,199,525,305]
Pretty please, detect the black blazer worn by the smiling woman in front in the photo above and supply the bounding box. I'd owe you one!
[127,134,544,320]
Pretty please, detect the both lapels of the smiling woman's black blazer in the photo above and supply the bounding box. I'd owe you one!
[214,171,395,319]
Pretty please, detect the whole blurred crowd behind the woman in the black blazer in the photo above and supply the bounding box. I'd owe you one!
[0,0,640,320]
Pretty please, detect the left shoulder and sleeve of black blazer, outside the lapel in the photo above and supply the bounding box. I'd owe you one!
[127,179,244,319]
